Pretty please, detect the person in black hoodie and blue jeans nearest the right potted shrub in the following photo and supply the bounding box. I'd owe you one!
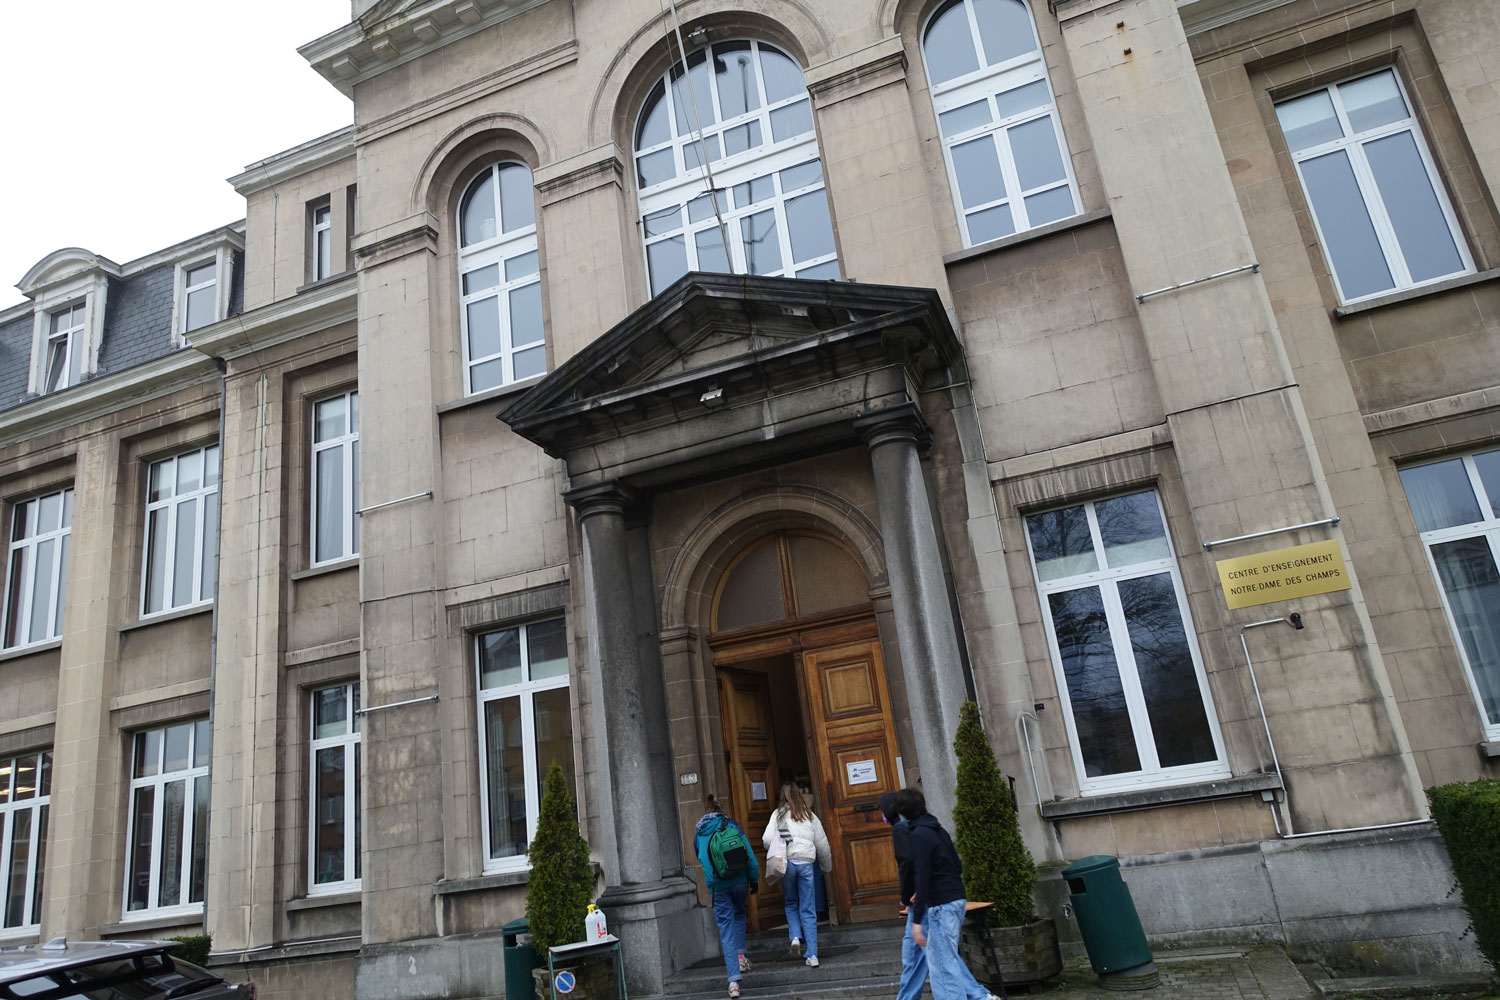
[900,789,996,1000]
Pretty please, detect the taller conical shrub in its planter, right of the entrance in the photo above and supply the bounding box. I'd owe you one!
[953,702,1062,985]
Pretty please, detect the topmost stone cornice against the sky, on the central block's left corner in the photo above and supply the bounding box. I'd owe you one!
[297,0,561,97]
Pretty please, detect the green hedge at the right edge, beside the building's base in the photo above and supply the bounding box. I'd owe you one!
[1427,781,1500,972]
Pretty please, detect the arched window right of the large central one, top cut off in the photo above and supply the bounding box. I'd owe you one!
[923,0,1079,246]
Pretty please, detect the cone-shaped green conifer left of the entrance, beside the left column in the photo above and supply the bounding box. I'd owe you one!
[527,763,594,960]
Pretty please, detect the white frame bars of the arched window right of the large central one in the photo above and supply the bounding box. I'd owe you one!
[918,0,1082,246]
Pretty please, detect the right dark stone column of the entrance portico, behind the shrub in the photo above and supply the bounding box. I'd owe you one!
[854,403,966,825]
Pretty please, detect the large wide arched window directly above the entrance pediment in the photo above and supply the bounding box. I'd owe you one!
[635,42,840,295]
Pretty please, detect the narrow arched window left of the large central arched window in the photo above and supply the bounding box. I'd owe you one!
[459,163,548,394]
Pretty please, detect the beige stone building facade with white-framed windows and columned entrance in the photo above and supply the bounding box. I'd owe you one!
[0,0,1500,999]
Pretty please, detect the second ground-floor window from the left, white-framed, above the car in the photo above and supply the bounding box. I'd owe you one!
[125,720,212,918]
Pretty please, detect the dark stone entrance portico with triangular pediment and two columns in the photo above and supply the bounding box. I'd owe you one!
[501,274,966,991]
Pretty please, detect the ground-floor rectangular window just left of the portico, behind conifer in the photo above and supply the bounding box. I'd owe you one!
[474,618,573,871]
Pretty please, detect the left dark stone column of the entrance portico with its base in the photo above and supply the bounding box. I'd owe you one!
[564,483,705,993]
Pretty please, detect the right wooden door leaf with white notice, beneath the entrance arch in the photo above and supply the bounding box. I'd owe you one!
[803,640,899,921]
